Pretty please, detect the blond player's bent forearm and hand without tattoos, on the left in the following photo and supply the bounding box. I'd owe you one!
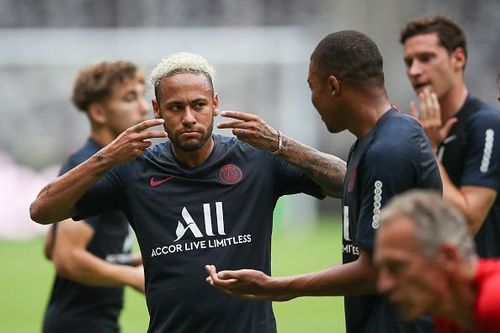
[30,119,167,224]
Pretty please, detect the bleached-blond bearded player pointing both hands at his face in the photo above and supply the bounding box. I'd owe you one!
[30,53,345,333]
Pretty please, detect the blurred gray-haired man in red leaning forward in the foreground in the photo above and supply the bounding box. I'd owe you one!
[374,191,500,333]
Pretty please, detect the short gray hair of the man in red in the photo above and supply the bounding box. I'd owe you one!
[380,190,476,261]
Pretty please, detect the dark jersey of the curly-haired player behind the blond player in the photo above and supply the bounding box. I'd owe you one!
[43,139,131,333]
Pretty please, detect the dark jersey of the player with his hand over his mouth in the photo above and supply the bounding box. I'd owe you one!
[438,96,500,257]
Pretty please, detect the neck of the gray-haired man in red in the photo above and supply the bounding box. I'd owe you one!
[431,259,477,332]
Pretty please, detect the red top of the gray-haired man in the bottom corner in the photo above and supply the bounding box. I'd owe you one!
[434,259,500,333]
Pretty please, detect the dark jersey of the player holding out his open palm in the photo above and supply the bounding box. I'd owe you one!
[342,109,442,333]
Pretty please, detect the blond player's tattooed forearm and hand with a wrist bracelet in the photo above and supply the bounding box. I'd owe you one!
[217,111,346,198]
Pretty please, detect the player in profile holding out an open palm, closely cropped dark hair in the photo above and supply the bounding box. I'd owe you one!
[206,31,441,333]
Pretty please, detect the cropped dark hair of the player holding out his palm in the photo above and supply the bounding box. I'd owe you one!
[311,30,384,88]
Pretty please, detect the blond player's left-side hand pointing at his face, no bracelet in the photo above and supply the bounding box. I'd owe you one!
[99,119,167,165]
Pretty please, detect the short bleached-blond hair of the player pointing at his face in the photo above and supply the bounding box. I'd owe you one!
[150,52,215,100]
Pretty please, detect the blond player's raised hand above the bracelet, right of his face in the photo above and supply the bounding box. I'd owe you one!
[217,111,279,152]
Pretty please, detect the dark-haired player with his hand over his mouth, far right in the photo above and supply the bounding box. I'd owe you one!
[400,16,500,257]
